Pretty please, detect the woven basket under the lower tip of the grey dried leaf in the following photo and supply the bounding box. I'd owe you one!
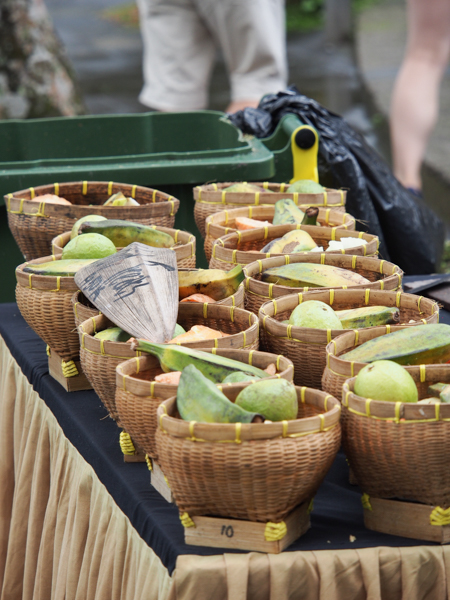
[78,302,259,421]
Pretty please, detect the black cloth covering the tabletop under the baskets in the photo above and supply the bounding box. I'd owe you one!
[0,304,442,574]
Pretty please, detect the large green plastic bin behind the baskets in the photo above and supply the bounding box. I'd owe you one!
[0,111,301,302]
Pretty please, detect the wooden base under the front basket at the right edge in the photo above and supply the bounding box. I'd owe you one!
[364,496,450,544]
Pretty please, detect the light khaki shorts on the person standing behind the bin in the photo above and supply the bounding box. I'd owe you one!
[137,0,287,111]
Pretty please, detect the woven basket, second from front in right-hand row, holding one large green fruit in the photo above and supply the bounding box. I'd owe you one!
[322,324,431,398]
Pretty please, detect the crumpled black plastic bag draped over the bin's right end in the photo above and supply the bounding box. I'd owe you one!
[230,88,445,275]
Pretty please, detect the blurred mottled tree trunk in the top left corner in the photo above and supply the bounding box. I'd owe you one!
[0,0,85,119]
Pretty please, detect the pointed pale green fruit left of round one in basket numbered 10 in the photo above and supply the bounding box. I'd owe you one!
[177,365,264,423]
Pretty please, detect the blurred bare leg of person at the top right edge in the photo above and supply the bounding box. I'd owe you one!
[390,0,450,189]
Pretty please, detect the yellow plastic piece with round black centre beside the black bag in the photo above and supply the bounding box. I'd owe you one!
[290,125,319,183]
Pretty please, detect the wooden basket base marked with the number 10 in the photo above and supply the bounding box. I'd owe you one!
[184,501,310,554]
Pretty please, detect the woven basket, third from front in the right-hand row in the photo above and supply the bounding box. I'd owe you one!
[259,289,439,390]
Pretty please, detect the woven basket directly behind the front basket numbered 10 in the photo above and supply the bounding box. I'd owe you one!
[116,348,294,459]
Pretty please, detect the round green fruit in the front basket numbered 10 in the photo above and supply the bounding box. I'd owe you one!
[235,379,298,421]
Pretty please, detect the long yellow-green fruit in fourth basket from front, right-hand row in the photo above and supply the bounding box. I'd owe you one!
[261,263,370,287]
